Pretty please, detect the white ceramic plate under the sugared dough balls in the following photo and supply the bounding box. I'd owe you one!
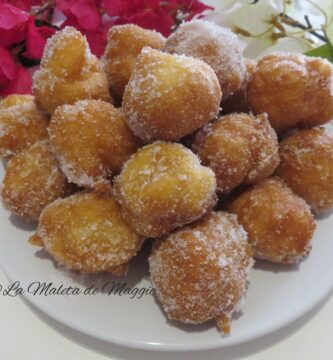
[0,166,333,350]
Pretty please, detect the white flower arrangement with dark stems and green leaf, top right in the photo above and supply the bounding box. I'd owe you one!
[210,0,333,62]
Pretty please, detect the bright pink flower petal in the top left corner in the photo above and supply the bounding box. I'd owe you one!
[0,4,29,47]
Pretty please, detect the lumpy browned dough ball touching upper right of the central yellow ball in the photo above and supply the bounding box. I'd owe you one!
[192,113,279,193]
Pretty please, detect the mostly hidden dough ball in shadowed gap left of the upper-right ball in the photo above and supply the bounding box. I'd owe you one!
[221,59,257,114]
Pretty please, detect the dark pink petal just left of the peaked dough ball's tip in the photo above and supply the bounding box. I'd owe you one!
[23,16,56,59]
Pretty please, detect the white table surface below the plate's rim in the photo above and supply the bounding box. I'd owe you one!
[0,271,333,360]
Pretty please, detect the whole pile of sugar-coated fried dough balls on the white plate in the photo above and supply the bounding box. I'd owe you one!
[0,20,333,333]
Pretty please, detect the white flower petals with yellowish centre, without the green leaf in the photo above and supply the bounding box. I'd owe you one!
[206,0,326,57]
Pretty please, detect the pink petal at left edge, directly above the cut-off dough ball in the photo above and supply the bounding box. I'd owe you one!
[0,47,31,96]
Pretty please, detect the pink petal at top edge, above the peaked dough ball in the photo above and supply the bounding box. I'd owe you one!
[56,0,101,31]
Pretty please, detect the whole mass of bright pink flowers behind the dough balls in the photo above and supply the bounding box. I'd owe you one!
[0,0,213,97]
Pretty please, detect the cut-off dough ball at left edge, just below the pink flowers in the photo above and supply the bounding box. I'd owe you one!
[0,95,48,159]
